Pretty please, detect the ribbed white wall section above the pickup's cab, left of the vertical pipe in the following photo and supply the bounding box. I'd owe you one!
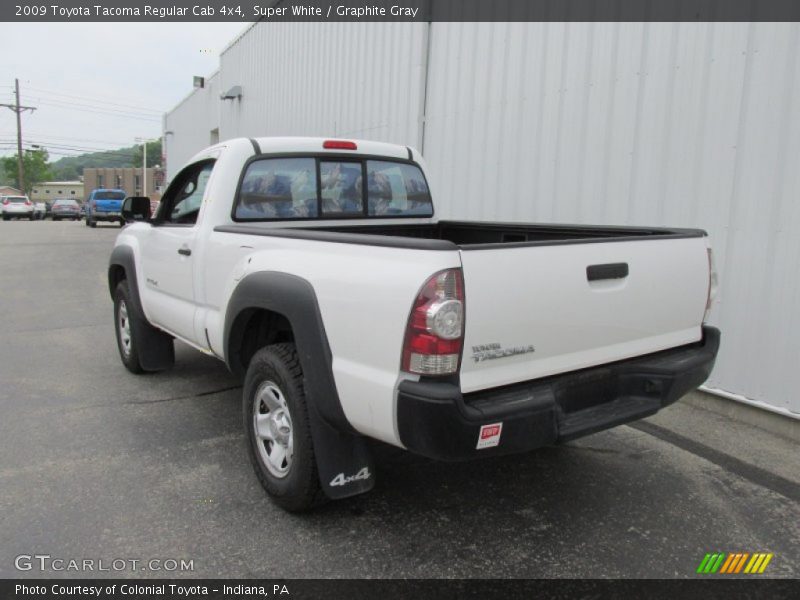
[220,23,427,144]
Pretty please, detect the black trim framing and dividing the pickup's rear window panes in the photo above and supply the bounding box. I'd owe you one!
[231,152,436,223]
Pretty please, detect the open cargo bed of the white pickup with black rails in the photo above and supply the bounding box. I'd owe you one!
[216,221,705,250]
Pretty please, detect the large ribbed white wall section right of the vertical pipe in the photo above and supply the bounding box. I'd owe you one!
[425,23,800,412]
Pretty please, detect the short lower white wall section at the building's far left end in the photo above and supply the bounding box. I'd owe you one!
[163,72,220,181]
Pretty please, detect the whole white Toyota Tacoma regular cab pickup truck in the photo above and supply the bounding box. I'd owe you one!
[108,138,720,510]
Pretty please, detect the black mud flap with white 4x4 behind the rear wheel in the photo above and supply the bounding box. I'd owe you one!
[308,403,375,500]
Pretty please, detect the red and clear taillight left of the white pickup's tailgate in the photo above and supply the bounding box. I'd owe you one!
[402,269,464,375]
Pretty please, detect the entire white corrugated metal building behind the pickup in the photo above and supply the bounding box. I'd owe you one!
[164,23,800,416]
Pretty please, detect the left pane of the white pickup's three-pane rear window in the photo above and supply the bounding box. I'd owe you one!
[234,158,317,220]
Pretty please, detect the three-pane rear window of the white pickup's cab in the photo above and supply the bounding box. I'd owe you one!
[232,156,433,221]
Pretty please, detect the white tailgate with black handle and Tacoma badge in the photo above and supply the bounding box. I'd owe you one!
[461,236,709,393]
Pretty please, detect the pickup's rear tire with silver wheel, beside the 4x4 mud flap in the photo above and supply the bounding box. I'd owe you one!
[242,344,325,512]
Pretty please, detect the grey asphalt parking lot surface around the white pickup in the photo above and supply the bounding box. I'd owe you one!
[0,221,800,578]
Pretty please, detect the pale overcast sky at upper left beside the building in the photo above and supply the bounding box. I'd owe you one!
[0,23,247,159]
